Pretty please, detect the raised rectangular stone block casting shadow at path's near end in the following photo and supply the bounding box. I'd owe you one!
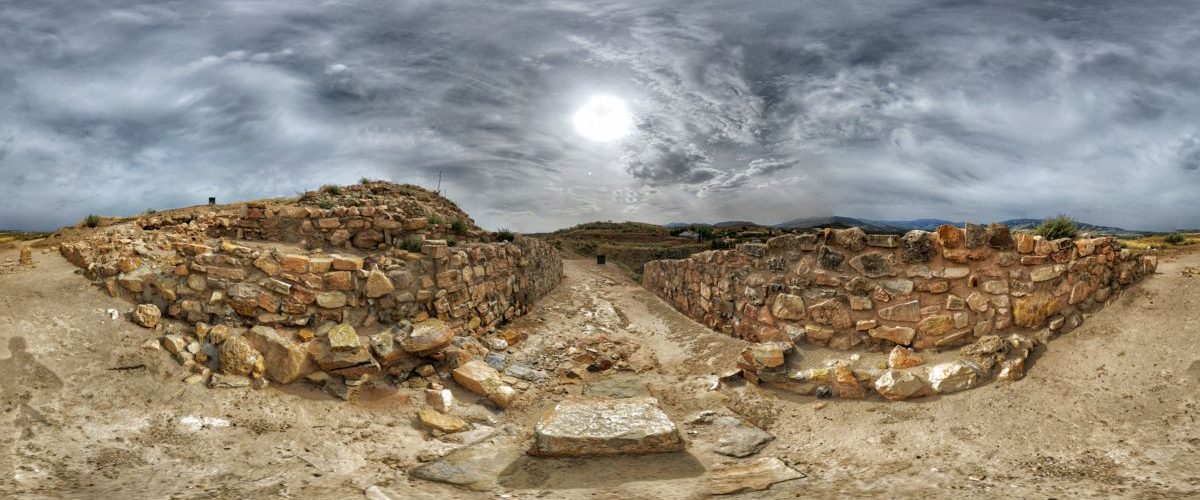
[529,397,684,457]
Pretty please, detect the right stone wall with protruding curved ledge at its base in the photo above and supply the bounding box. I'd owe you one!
[643,224,1157,399]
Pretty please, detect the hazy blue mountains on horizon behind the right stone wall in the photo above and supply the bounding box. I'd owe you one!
[665,216,1153,235]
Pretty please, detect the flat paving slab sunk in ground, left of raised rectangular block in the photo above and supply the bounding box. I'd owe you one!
[409,426,523,492]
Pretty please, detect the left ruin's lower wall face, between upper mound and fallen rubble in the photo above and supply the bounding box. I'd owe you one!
[60,231,562,335]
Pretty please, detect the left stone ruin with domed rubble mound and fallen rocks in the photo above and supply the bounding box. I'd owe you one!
[60,183,563,398]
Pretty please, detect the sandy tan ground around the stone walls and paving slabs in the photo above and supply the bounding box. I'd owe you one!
[0,244,1200,499]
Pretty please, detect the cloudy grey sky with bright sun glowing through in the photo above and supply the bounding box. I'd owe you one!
[0,0,1200,231]
